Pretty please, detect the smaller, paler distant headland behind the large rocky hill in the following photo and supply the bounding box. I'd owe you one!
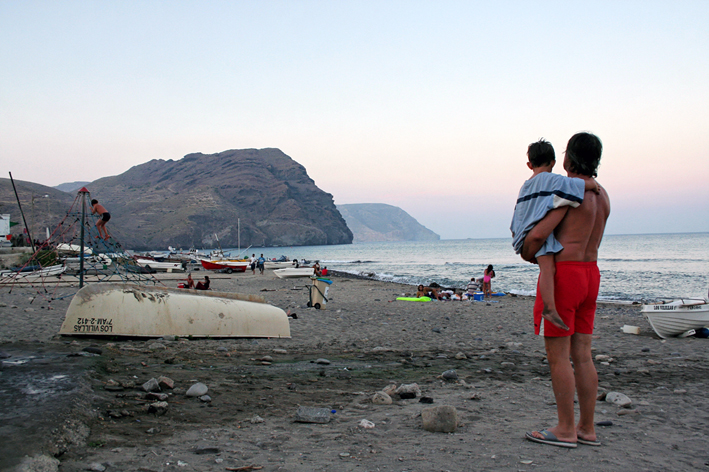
[337,203,441,243]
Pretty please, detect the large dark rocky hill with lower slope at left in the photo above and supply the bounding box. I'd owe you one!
[0,149,352,250]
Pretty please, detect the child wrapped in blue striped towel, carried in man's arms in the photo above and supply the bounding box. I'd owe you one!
[510,139,599,331]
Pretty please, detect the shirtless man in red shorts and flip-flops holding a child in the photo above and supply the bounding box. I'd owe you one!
[522,133,610,447]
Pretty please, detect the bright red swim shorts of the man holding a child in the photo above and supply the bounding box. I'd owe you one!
[534,261,601,337]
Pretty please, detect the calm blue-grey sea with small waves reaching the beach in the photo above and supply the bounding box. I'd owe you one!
[218,233,709,303]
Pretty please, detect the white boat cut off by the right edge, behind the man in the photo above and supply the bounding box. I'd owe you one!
[641,298,709,338]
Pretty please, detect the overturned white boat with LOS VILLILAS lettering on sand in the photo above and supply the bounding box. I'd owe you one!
[59,283,290,338]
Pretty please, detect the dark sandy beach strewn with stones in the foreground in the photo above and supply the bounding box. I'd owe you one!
[0,271,709,472]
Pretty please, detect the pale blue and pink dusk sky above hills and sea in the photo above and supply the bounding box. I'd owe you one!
[0,0,709,239]
